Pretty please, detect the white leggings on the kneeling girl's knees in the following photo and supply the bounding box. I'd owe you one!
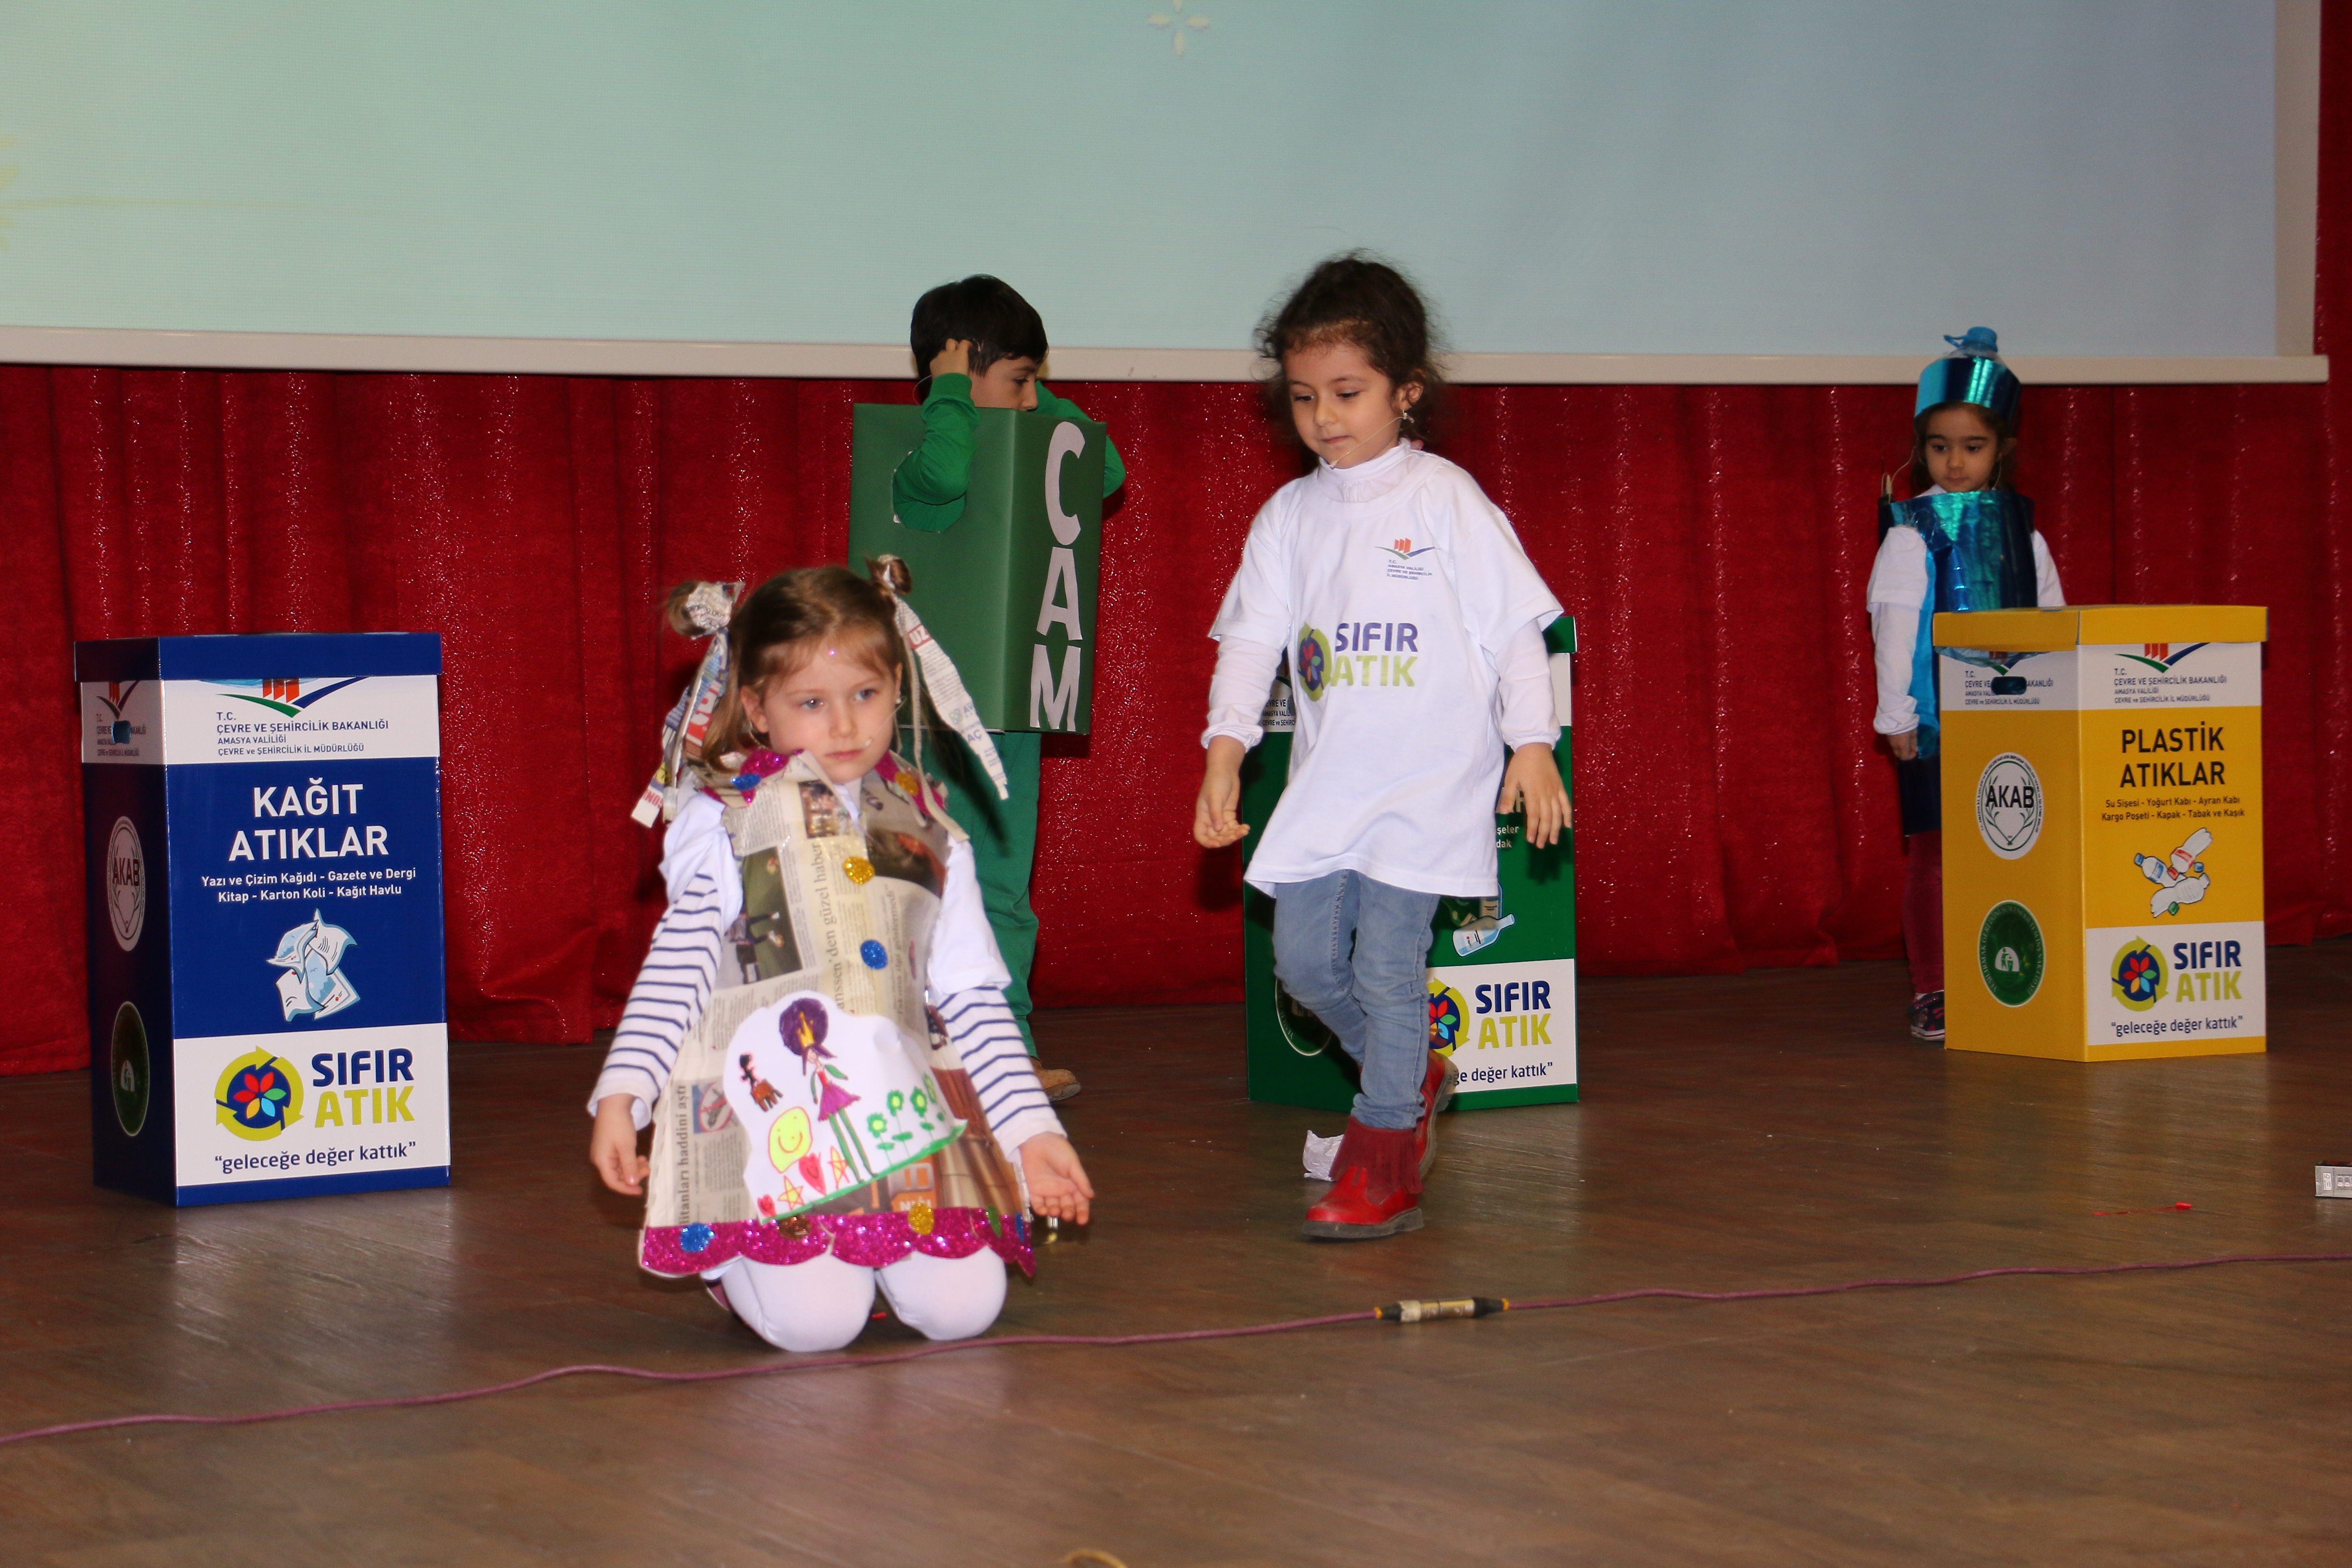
[703,1248,1004,1352]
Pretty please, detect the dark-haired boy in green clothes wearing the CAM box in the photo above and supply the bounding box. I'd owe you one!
[891,275,1127,1100]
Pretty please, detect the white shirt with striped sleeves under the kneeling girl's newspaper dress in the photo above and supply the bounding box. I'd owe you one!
[588,787,1061,1154]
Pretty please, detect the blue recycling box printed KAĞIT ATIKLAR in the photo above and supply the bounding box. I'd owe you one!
[73,632,449,1204]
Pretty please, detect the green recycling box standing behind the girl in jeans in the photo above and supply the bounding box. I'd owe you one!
[1242,616,1576,1112]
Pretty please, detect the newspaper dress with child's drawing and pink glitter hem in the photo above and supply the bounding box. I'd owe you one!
[640,752,1032,1277]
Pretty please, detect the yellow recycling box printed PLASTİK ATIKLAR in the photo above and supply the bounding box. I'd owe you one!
[1933,604,2267,1063]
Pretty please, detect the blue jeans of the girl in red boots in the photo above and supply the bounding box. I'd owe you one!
[1275,872,1437,1128]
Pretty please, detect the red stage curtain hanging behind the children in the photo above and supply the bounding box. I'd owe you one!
[0,31,2352,1072]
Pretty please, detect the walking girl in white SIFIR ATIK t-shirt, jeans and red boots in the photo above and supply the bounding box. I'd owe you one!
[1192,256,1569,1241]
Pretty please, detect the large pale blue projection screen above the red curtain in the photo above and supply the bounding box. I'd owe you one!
[0,0,2324,381]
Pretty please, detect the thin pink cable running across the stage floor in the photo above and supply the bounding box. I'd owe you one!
[0,1253,2352,1448]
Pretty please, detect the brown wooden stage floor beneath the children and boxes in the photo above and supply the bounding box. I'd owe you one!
[0,943,2352,1568]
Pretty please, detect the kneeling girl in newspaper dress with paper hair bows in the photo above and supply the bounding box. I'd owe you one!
[588,562,1093,1352]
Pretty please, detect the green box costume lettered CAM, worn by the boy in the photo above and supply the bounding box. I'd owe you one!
[849,402,1110,736]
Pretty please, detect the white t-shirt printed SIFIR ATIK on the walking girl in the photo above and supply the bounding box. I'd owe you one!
[1209,444,1559,898]
